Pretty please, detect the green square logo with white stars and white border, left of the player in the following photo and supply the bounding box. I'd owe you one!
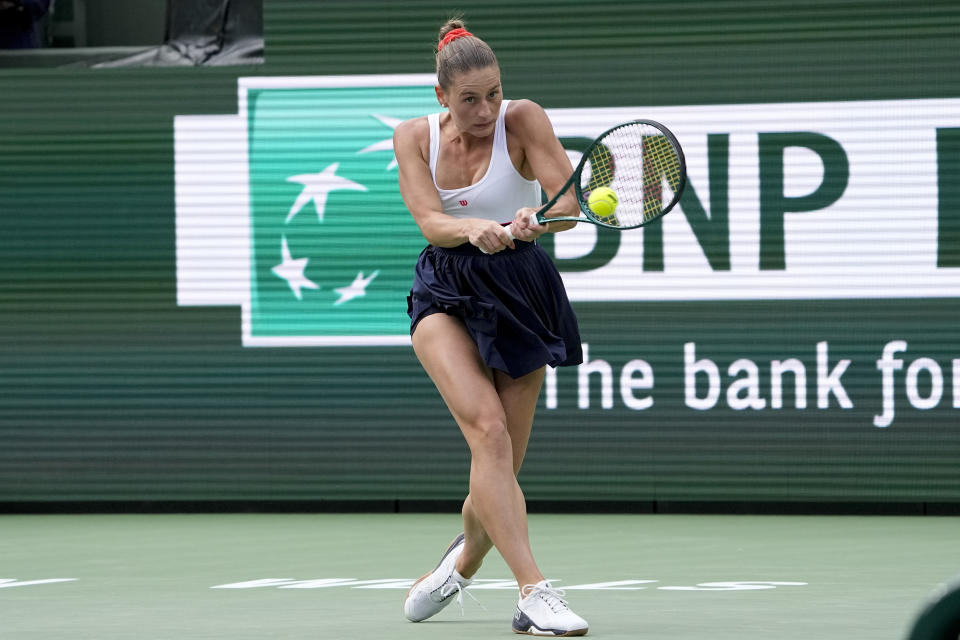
[175,75,437,346]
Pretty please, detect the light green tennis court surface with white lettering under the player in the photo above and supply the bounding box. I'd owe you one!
[0,514,960,640]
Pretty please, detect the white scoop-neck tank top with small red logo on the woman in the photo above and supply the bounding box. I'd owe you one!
[427,100,540,223]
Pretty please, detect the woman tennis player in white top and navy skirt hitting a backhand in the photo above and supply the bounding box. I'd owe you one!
[394,19,587,636]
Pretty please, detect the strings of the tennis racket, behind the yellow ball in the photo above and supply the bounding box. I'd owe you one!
[584,122,682,227]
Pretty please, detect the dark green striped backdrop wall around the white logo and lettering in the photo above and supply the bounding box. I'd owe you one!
[0,0,960,503]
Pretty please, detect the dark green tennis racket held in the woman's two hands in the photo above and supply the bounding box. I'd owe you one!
[507,120,687,240]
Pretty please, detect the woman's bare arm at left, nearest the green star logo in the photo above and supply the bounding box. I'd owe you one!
[393,118,514,253]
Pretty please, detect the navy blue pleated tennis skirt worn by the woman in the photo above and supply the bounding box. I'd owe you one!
[407,240,583,378]
